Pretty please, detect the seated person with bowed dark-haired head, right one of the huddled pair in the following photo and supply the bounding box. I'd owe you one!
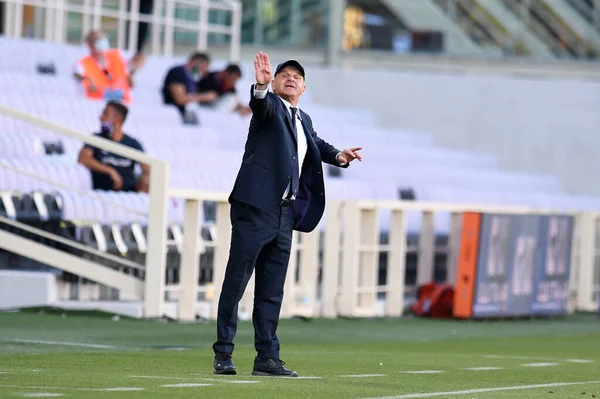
[198,64,251,115]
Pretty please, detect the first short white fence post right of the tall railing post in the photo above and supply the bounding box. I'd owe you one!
[177,199,202,321]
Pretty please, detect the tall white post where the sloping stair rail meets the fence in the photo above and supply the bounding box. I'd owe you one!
[144,161,169,318]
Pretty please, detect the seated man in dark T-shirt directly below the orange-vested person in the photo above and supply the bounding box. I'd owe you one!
[78,101,150,192]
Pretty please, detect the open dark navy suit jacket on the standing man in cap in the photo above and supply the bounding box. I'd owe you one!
[229,86,348,232]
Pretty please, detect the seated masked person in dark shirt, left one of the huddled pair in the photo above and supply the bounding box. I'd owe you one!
[162,53,218,120]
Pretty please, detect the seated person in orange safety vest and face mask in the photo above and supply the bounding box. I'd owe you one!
[73,31,133,104]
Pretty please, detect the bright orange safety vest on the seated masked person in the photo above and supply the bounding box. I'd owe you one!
[81,49,131,104]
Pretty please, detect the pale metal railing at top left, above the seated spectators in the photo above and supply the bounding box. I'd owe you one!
[1,0,242,62]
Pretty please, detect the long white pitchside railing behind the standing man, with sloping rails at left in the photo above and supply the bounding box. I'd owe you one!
[0,106,600,320]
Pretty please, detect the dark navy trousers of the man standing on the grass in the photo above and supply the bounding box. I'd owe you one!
[213,202,294,359]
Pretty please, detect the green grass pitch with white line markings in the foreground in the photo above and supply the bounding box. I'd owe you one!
[0,311,600,399]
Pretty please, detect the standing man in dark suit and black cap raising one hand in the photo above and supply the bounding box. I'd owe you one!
[213,53,361,377]
